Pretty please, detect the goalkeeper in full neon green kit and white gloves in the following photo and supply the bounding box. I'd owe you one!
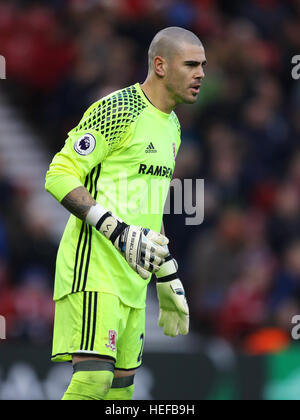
[46,27,206,400]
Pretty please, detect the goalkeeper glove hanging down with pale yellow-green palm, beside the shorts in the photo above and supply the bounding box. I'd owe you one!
[155,253,189,337]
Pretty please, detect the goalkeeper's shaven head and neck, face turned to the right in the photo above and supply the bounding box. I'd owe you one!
[142,26,206,113]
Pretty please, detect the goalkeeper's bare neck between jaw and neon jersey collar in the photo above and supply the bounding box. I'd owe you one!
[141,77,176,114]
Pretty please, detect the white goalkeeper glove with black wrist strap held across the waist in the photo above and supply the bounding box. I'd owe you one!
[86,204,169,280]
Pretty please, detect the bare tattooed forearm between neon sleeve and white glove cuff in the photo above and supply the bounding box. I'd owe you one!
[61,186,97,220]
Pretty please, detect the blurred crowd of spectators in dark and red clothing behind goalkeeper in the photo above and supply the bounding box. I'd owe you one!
[0,0,300,353]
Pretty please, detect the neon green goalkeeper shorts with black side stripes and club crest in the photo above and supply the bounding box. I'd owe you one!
[51,292,145,370]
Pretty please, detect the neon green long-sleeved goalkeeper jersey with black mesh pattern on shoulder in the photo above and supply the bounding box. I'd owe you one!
[46,83,180,308]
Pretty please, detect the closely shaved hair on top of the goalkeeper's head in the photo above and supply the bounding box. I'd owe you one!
[148,26,202,70]
